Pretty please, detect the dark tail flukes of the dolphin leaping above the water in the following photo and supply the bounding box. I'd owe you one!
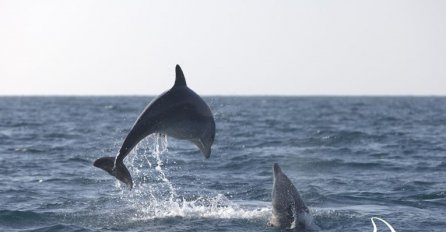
[93,157,133,189]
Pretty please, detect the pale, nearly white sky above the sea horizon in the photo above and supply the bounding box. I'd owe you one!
[0,0,446,95]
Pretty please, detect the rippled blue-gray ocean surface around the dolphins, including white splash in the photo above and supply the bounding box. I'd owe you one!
[0,97,446,232]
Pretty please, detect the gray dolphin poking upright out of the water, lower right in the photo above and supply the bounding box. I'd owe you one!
[270,163,311,231]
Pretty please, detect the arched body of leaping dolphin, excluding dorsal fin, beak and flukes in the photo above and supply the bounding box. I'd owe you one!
[116,86,215,160]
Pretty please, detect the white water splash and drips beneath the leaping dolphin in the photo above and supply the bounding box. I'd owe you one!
[118,134,271,220]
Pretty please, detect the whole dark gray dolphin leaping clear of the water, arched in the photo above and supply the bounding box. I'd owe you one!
[93,65,215,189]
